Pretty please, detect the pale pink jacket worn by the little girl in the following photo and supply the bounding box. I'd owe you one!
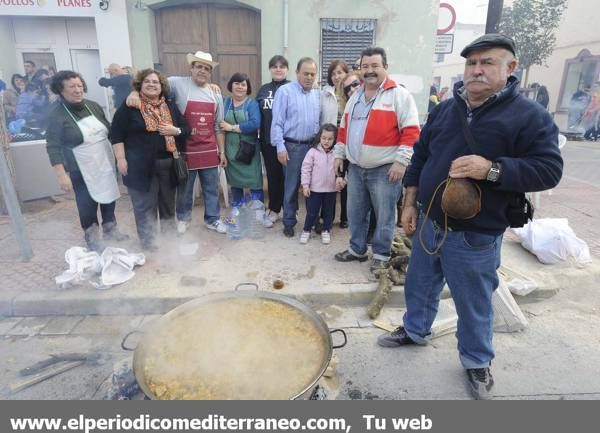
[300,144,337,192]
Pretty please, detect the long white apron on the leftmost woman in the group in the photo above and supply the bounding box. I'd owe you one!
[63,104,121,204]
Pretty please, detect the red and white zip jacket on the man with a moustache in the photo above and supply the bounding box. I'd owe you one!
[334,78,420,168]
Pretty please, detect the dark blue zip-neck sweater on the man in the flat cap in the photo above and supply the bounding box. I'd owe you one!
[404,77,563,234]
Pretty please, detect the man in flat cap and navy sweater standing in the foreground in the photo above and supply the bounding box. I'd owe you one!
[378,34,563,399]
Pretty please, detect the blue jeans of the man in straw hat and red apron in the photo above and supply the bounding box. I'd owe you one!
[177,167,221,224]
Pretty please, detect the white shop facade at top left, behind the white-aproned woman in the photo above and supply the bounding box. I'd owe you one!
[0,0,132,115]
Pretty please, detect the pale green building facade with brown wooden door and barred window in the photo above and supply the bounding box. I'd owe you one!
[127,0,439,113]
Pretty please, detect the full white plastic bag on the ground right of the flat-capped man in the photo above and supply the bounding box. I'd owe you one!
[512,218,592,266]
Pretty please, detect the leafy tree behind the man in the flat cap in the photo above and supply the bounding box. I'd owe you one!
[498,0,567,86]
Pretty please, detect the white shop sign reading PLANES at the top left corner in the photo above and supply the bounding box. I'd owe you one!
[0,0,99,17]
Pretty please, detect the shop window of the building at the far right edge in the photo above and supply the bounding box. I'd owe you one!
[557,50,600,111]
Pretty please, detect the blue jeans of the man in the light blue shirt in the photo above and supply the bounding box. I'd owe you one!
[283,142,310,227]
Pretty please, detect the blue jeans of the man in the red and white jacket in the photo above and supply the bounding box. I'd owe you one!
[347,164,402,261]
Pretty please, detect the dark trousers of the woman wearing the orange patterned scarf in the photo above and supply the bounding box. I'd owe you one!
[129,158,176,245]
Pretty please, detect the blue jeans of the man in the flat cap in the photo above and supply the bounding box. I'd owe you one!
[404,214,502,368]
